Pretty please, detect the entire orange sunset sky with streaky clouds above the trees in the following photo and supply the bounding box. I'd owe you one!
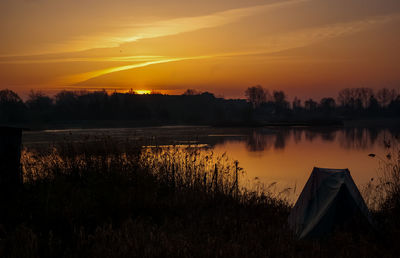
[0,0,400,98]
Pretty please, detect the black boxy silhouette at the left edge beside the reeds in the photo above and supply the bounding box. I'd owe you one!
[0,127,22,189]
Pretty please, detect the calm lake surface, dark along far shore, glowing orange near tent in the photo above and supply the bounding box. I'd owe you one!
[23,127,399,198]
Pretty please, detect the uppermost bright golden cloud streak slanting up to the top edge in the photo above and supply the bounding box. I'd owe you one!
[36,0,311,51]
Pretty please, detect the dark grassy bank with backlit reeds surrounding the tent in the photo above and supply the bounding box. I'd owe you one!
[0,138,400,257]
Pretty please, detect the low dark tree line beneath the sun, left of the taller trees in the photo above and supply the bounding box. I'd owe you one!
[0,89,246,124]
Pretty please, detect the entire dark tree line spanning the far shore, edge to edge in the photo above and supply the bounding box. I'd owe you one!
[0,86,400,124]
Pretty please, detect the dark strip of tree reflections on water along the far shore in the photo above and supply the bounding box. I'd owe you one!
[23,127,400,152]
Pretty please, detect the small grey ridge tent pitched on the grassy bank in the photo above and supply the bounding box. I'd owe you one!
[289,167,372,238]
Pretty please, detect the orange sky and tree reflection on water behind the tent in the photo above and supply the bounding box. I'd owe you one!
[209,127,399,203]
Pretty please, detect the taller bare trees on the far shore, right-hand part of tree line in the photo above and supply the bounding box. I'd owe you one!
[245,85,400,119]
